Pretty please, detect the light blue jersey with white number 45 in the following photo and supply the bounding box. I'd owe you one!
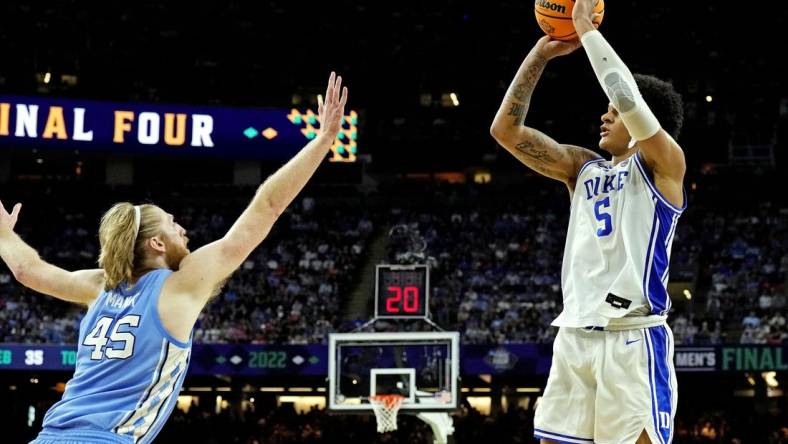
[38,269,191,443]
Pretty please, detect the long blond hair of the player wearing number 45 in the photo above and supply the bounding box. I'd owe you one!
[98,202,161,291]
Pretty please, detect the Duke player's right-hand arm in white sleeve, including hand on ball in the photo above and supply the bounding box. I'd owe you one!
[572,0,686,184]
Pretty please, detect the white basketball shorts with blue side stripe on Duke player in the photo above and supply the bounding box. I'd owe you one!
[534,325,677,444]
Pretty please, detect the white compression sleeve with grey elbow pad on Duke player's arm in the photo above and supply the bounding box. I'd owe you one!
[580,31,661,140]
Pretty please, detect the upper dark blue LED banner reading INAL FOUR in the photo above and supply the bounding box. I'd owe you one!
[0,96,358,162]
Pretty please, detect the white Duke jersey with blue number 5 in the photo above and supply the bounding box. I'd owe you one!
[553,153,687,329]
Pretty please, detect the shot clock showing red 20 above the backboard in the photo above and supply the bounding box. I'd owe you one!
[375,265,430,319]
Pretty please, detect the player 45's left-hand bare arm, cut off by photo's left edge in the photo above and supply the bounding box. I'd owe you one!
[0,202,104,305]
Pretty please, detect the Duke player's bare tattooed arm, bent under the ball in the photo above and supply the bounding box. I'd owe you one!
[490,36,599,192]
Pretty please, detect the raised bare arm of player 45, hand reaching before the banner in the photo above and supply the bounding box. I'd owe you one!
[164,72,347,304]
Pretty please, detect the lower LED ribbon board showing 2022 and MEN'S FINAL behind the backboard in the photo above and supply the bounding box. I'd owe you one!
[0,344,788,376]
